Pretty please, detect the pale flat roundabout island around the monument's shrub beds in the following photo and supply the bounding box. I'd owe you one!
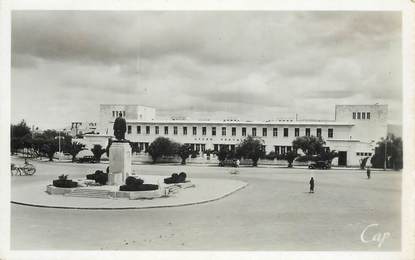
[11,175,247,210]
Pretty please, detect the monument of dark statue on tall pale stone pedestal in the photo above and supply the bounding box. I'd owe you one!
[108,113,131,185]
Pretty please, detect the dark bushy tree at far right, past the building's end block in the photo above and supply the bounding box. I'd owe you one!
[370,135,403,170]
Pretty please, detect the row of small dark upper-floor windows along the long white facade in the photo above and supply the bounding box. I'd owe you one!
[127,125,334,138]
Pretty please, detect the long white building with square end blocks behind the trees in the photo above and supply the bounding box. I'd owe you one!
[86,104,388,166]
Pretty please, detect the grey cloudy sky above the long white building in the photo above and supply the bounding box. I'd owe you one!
[11,11,402,128]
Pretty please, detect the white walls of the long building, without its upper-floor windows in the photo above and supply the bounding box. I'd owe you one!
[87,105,388,165]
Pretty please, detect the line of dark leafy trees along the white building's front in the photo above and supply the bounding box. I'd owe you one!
[10,120,403,170]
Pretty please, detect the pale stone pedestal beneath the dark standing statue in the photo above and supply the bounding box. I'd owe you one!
[108,142,131,185]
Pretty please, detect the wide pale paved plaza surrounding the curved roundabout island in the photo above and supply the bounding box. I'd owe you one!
[11,159,401,250]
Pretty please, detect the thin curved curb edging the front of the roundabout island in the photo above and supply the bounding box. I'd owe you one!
[10,183,248,210]
